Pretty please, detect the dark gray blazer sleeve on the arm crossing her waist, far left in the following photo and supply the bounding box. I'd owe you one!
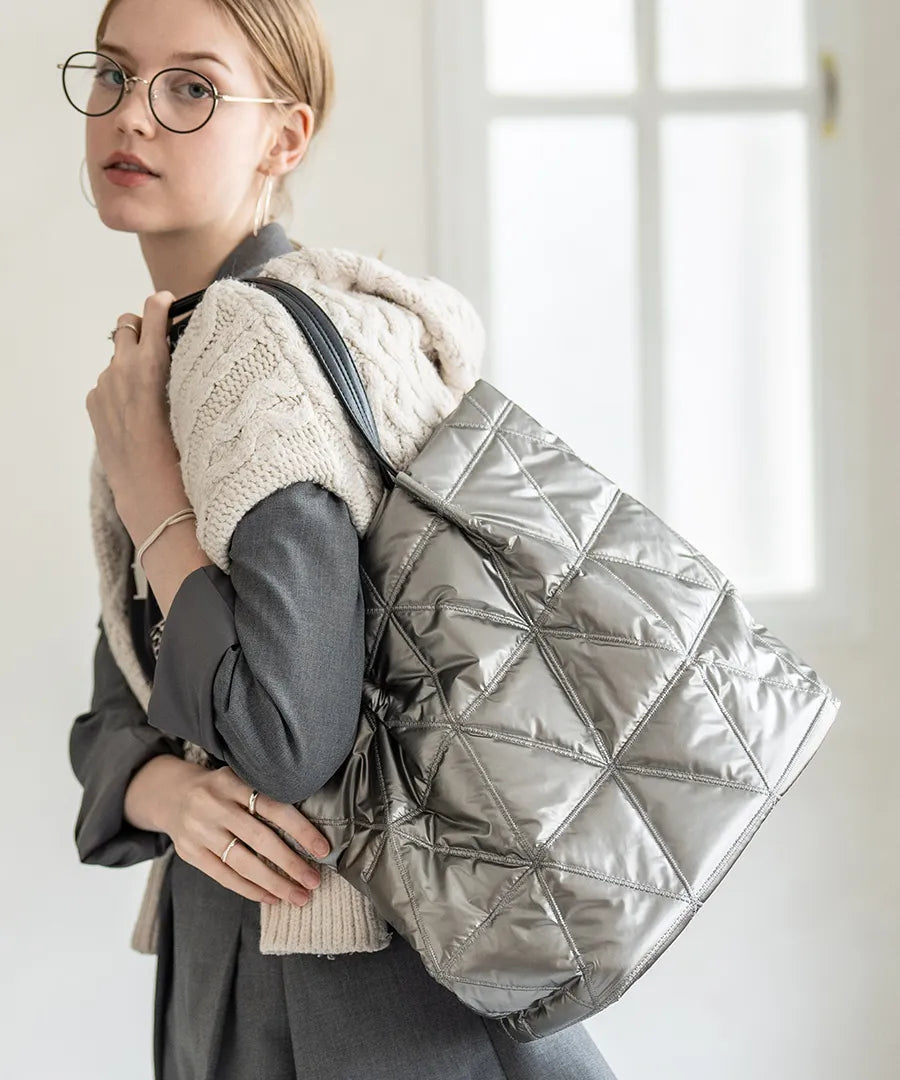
[69,621,184,866]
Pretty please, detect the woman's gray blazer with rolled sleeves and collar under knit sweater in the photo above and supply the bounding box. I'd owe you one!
[69,222,365,866]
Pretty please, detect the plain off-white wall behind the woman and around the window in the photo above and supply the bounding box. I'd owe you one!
[0,0,900,1080]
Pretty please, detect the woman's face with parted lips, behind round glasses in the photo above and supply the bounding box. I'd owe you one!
[85,0,293,232]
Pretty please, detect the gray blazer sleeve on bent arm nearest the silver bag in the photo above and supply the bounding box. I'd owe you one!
[148,481,365,804]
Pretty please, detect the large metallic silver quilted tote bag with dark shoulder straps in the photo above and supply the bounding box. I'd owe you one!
[179,278,839,1042]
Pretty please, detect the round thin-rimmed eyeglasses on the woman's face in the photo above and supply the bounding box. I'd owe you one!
[56,52,292,135]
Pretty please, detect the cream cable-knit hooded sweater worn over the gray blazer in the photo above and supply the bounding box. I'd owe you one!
[91,246,485,955]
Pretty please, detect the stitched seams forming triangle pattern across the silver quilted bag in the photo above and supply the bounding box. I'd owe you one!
[347,381,836,1038]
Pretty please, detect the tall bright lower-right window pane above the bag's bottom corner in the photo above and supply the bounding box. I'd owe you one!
[661,112,816,593]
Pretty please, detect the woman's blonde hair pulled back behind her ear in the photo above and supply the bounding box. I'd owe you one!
[94,0,334,238]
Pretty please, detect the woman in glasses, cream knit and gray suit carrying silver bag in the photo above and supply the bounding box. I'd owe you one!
[64,0,612,1080]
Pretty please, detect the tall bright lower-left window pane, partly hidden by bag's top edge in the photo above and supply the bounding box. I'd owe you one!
[485,117,641,495]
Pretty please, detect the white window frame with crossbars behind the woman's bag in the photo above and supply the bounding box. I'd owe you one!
[426,0,873,649]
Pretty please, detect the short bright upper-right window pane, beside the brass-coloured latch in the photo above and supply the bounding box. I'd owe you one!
[658,0,806,89]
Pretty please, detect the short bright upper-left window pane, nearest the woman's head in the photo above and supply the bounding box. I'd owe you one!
[484,0,635,94]
